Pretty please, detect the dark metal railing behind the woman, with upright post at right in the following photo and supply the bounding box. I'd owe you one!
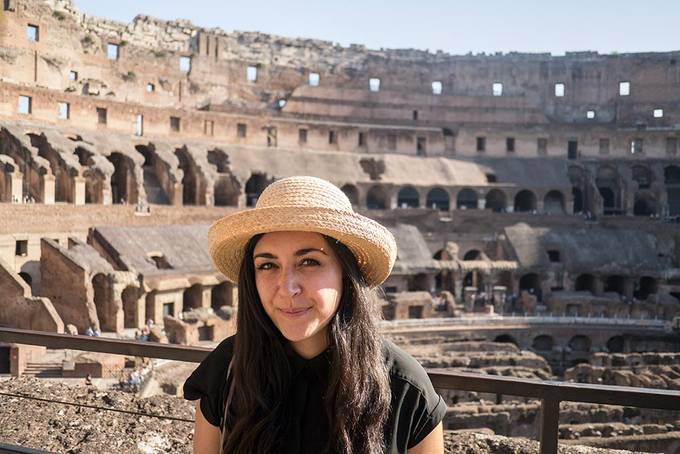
[0,328,680,454]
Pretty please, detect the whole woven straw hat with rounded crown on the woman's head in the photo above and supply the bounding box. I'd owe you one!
[208,176,397,287]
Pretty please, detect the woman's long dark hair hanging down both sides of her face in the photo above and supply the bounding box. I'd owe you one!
[222,235,391,454]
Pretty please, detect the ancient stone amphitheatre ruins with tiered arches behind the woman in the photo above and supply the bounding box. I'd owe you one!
[0,0,680,453]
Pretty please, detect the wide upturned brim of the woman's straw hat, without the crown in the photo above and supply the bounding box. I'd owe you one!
[208,206,397,287]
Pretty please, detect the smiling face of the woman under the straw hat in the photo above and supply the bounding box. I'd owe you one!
[253,232,342,358]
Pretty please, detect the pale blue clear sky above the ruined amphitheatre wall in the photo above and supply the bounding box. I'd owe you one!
[75,0,680,55]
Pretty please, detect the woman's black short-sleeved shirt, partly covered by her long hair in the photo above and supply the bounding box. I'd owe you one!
[184,337,446,454]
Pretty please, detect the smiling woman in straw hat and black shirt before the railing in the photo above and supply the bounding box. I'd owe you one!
[184,177,446,454]
